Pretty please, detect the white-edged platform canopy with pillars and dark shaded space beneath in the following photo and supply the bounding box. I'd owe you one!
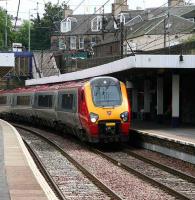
[26,55,195,127]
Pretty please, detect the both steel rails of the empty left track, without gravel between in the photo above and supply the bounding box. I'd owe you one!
[14,124,122,200]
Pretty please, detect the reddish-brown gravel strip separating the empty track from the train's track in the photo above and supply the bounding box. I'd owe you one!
[20,129,175,200]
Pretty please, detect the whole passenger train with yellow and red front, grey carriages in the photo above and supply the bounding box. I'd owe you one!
[0,77,130,143]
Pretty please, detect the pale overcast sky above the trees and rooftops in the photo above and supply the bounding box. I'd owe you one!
[0,0,195,19]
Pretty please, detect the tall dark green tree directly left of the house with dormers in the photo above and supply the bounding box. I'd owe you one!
[31,2,63,50]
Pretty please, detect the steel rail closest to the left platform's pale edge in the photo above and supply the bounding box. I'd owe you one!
[23,139,66,200]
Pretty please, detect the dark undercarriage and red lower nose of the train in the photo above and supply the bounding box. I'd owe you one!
[0,113,129,143]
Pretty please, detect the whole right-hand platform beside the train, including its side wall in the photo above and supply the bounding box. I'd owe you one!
[130,121,195,164]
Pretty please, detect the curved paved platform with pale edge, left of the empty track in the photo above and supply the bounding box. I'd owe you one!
[0,120,57,200]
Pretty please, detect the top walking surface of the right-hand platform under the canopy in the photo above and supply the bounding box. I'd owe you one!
[132,121,195,147]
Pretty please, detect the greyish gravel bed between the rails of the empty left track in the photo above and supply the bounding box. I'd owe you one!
[19,130,110,200]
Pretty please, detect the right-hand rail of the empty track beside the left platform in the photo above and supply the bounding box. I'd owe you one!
[13,124,122,200]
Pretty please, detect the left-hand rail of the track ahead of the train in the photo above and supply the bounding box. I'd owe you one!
[91,148,190,200]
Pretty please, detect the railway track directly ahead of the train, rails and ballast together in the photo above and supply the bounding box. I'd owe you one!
[92,146,195,200]
